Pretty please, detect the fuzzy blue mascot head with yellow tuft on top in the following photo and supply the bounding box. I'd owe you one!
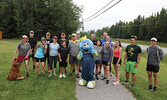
[79,36,93,52]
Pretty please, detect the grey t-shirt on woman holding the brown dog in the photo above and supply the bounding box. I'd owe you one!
[17,42,31,56]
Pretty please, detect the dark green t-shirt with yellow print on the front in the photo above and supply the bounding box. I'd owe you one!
[125,45,142,62]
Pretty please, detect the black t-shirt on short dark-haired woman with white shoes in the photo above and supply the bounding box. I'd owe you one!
[59,47,69,60]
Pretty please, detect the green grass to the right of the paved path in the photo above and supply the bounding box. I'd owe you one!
[112,47,167,100]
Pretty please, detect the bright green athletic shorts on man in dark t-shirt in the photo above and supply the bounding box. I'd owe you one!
[125,61,137,73]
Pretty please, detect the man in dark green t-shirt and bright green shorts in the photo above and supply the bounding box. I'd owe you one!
[123,37,142,88]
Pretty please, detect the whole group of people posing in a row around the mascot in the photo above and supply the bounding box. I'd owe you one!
[14,31,163,92]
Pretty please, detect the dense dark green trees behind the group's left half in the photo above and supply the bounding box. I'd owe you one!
[0,0,82,38]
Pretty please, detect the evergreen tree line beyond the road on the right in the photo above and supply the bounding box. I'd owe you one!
[92,8,167,42]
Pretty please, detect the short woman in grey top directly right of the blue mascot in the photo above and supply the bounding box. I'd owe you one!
[94,40,102,80]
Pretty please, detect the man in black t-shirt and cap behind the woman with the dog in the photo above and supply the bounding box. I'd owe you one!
[28,31,37,71]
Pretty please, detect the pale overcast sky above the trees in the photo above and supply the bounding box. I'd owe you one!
[73,0,167,32]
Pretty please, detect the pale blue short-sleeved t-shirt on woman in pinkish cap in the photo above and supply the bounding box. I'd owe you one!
[49,43,60,56]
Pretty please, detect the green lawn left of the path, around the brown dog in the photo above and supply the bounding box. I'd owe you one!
[0,39,76,100]
